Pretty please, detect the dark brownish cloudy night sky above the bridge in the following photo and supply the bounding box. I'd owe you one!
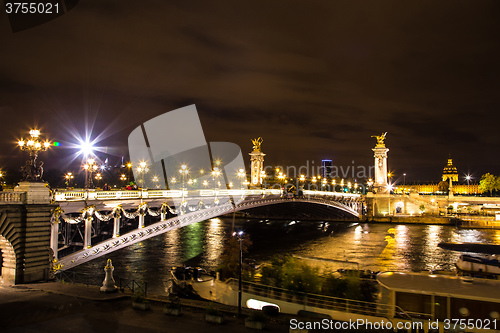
[0,0,500,182]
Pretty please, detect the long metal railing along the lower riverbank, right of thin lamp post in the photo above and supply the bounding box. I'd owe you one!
[227,279,411,320]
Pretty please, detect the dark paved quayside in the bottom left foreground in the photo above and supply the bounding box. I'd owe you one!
[0,282,289,333]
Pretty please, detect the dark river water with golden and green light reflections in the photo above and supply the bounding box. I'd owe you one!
[72,217,500,294]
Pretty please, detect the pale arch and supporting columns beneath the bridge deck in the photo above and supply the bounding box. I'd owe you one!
[51,191,362,271]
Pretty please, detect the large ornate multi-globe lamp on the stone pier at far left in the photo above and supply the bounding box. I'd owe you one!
[18,129,50,182]
